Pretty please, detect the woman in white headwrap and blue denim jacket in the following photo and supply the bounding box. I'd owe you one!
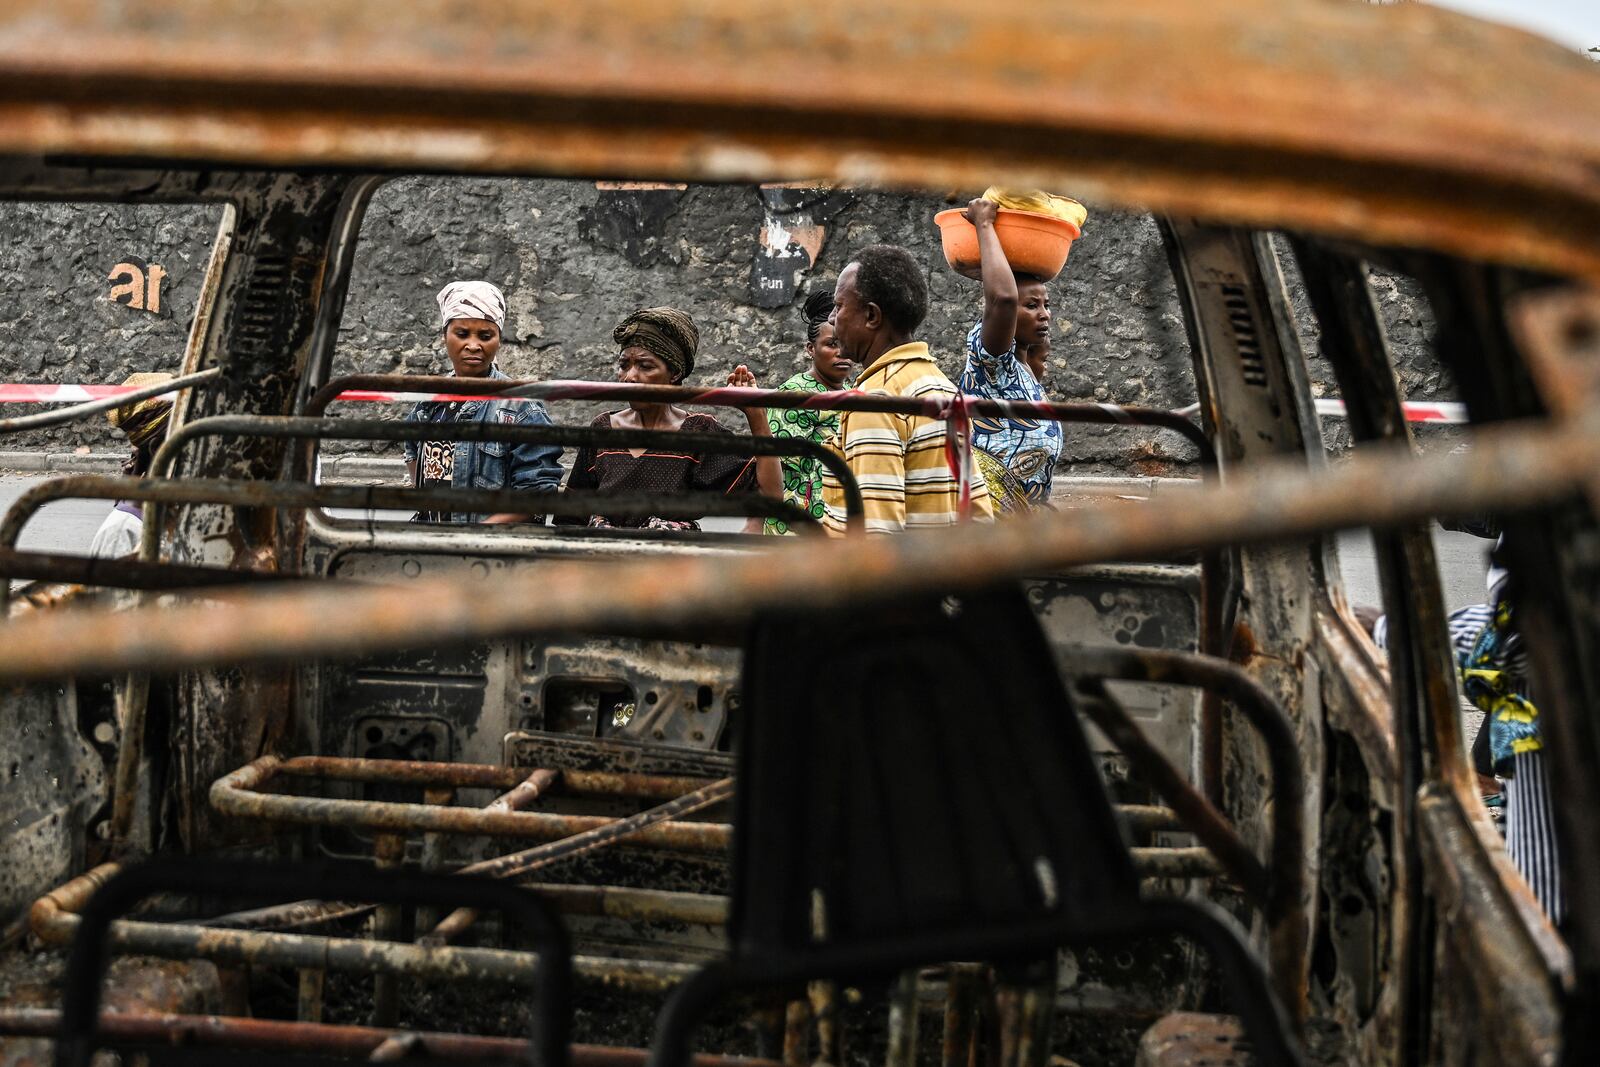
[405,282,562,523]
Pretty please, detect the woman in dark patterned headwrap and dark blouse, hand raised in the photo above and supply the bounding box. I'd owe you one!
[566,307,784,530]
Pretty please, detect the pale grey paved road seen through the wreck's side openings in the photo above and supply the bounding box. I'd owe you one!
[0,475,1490,609]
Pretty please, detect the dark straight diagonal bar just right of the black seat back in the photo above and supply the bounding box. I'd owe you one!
[1077,677,1270,905]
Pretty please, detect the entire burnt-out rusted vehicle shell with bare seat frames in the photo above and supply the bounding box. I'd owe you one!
[0,0,1600,1067]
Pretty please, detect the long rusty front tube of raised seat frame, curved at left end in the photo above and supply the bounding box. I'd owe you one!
[211,755,731,857]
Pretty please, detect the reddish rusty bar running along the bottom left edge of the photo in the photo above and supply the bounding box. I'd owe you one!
[0,1008,779,1067]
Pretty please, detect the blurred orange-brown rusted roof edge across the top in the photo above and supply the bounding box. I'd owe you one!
[0,0,1600,278]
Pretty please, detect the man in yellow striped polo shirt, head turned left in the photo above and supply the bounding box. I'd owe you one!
[822,245,994,534]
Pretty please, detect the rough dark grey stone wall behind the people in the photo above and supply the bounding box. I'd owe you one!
[0,178,1453,477]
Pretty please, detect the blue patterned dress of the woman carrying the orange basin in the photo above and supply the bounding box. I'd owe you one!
[960,322,1062,507]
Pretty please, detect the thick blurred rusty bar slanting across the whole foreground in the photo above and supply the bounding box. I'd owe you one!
[0,424,1600,683]
